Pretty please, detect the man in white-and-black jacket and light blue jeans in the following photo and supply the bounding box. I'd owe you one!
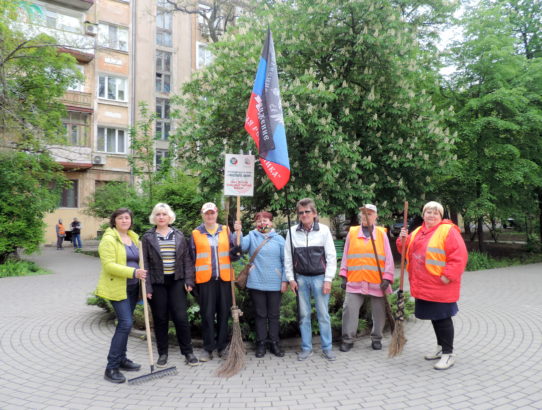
[284,198,337,360]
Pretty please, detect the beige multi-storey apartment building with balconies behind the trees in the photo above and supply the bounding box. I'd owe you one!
[15,0,215,246]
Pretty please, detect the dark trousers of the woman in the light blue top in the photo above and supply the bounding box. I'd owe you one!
[250,289,282,343]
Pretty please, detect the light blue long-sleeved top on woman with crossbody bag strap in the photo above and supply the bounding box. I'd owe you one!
[241,230,286,291]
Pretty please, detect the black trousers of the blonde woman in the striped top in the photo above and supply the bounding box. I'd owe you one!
[149,275,193,355]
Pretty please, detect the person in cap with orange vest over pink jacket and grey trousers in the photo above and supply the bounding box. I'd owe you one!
[339,204,395,352]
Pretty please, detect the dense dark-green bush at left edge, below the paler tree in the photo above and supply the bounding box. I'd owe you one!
[0,151,66,263]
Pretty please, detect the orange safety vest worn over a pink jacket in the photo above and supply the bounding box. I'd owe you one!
[346,226,386,283]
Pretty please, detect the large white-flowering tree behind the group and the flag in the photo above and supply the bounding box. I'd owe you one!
[173,0,455,221]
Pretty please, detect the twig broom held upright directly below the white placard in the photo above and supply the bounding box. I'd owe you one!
[216,196,250,377]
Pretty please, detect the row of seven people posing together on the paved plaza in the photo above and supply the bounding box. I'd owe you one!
[96,198,467,383]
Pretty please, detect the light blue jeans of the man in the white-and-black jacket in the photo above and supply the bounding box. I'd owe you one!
[297,275,331,351]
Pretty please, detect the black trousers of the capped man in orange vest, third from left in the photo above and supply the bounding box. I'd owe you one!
[198,279,232,352]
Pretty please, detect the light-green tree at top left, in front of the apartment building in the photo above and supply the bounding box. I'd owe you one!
[0,0,81,151]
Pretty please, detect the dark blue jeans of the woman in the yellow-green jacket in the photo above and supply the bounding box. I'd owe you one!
[107,284,139,369]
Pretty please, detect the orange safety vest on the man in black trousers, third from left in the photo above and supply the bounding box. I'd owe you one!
[192,229,231,283]
